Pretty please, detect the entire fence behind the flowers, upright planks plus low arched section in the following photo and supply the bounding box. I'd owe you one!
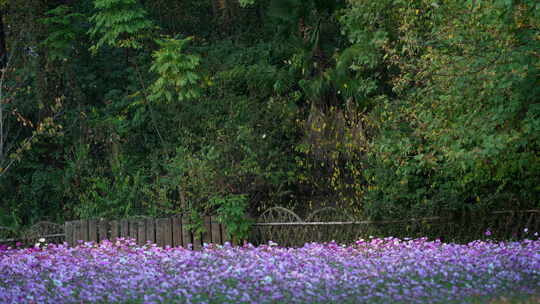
[4,207,540,249]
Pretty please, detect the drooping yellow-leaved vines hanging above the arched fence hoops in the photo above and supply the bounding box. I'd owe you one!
[295,106,367,216]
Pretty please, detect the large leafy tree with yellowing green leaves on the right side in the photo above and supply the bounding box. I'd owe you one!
[342,1,539,217]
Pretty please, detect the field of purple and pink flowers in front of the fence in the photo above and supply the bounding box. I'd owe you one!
[0,238,540,303]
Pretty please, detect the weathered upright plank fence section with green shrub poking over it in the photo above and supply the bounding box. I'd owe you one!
[64,216,230,250]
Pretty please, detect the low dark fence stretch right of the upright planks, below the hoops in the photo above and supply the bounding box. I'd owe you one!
[250,208,540,247]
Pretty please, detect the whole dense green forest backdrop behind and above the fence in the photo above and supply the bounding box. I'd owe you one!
[0,0,540,233]
